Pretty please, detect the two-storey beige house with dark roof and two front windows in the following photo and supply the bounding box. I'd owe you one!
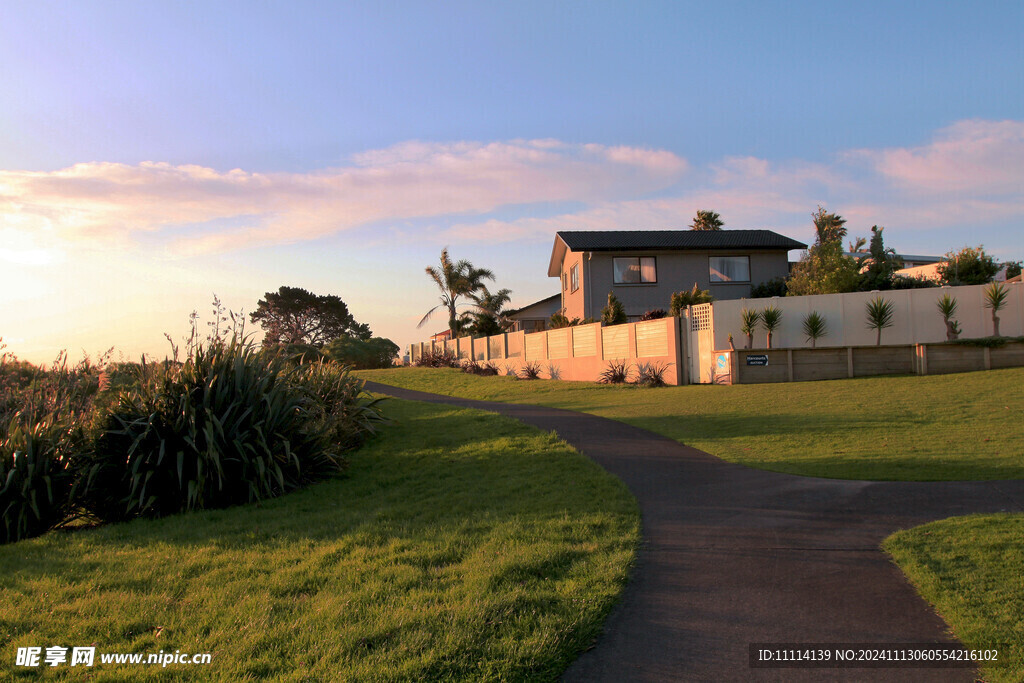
[548,230,807,319]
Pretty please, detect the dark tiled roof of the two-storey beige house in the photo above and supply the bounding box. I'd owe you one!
[557,230,807,252]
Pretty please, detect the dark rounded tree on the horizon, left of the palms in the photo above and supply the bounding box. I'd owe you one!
[250,287,371,348]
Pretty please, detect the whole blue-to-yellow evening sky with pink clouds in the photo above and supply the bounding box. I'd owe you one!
[0,0,1024,362]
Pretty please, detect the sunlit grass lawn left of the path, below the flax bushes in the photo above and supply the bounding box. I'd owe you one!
[0,401,639,681]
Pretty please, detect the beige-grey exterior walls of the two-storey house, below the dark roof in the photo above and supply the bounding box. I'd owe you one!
[562,251,790,319]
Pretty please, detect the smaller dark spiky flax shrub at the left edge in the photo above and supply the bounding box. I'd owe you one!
[0,413,79,544]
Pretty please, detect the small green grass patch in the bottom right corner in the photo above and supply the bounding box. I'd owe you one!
[883,514,1024,682]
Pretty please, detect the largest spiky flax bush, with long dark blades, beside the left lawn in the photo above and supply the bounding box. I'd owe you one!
[77,340,344,520]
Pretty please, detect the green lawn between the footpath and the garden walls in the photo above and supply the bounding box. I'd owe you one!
[356,368,1024,481]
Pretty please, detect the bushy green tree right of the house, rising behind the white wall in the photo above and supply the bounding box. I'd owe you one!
[786,206,859,296]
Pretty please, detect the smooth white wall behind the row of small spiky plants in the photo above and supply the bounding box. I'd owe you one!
[713,283,1024,349]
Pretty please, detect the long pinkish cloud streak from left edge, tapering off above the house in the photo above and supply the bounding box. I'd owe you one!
[0,140,686,253]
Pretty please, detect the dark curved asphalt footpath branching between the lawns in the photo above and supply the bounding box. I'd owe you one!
[367,382,1024,681]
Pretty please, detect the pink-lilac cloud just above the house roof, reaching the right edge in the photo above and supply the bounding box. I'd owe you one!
[441,121,1024,249]
